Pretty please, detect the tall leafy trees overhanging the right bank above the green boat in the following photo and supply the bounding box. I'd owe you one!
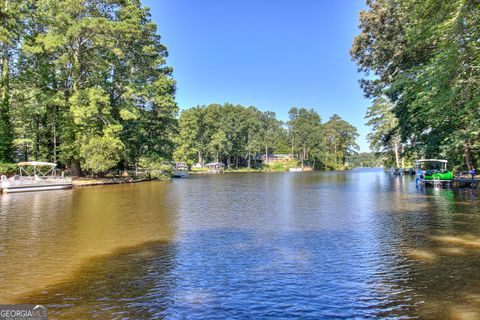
[351,0,480,168]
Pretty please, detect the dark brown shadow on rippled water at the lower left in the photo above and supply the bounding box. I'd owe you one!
[14,241,175,319]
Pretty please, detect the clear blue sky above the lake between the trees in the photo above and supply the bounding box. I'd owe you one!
[142,0,369,151]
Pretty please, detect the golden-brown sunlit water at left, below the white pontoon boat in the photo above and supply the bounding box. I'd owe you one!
[0,182,177,303]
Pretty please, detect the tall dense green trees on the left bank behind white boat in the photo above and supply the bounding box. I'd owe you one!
[0,0,178,174]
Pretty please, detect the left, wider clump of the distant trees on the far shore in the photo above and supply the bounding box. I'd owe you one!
[175,103,284,168]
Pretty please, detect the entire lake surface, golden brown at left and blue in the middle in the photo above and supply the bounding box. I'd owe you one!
[0,169,480,319]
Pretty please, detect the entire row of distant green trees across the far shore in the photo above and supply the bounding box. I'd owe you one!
[175,103,358,168]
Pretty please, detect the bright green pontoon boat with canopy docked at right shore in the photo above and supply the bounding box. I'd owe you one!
[415,159,453,185]
